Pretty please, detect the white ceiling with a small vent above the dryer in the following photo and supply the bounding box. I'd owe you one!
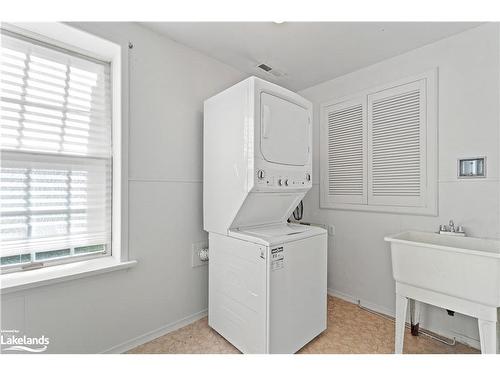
[142,22,480,91]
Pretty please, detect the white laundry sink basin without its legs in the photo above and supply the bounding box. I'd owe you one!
[385,232,500,306]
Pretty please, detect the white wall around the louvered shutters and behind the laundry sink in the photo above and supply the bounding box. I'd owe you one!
[301,24,500,344]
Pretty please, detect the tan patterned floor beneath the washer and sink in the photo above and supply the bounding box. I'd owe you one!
[129,297,478,354]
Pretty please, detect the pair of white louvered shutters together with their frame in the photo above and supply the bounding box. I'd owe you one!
[320,71,437,215]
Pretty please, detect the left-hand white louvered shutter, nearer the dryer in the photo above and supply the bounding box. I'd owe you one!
[322,98,367,204]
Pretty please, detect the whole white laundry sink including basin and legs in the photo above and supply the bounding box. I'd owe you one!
[385,231,500,353]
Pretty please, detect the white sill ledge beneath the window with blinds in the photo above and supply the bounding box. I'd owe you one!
[0,257,137,295]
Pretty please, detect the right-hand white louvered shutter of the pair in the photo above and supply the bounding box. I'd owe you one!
[368,79,426,207]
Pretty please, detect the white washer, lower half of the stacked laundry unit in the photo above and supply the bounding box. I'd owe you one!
[208,224,327,353]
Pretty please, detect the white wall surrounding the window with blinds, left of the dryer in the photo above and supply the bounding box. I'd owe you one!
[1,23,244,353]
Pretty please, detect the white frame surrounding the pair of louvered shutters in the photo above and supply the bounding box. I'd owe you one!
[319,67,438,216]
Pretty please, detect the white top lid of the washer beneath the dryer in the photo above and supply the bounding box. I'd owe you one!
[229,223,326,246]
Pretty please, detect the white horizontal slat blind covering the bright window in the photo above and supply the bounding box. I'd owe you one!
[0,32,112,267]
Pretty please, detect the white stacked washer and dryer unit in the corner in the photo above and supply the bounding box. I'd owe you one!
[203,77,327,353]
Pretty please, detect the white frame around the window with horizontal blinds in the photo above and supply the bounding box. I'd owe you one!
[1,22,123,275]
